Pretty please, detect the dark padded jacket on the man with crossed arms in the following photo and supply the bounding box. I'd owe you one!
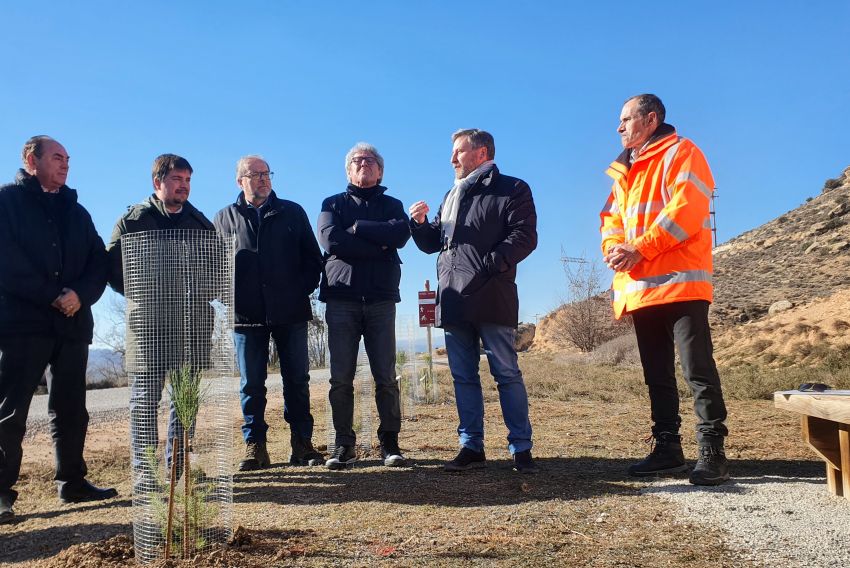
[319,184,410,303]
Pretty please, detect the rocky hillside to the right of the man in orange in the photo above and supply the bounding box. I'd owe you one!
[711,168,850,366]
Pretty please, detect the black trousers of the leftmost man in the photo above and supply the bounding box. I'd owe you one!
[0,335,89,501]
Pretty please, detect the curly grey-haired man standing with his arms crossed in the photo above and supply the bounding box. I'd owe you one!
[319,142,410,469]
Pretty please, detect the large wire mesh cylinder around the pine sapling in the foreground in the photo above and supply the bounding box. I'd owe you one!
[121,230,236,563]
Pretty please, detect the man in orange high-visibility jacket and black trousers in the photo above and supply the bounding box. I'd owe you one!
[600,94,729,485]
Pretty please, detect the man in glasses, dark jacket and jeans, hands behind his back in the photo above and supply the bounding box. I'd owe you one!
[213,156,324,471]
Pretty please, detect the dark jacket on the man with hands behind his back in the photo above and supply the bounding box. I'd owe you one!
[213,192,322,327]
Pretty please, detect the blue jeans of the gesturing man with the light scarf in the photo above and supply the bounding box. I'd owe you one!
[445,324,532,454]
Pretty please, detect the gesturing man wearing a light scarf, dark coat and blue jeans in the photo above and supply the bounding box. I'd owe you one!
[410,129,537,473]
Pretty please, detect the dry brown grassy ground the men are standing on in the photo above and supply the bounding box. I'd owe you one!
[0,354,822,568]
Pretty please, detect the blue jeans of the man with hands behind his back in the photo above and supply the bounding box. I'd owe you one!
[233,322,313,443]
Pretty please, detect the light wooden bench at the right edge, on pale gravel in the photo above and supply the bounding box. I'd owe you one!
[773,391,850,499]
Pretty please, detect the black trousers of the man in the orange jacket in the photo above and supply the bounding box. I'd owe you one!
[632,300,728,444]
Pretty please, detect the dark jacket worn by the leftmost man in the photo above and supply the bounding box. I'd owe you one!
[0,166,107,342]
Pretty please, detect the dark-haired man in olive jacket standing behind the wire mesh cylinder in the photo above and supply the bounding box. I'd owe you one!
[106,154,215,495]
